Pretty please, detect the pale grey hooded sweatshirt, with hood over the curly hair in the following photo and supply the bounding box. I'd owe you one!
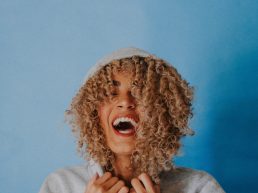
[39,47,224,193]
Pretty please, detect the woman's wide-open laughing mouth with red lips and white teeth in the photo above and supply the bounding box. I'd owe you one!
[112,117,137,136]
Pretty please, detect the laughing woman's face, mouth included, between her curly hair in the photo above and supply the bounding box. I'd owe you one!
[98,72,139,155]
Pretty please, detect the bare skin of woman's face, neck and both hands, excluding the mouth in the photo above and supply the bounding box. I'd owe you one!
[85,73,160,193]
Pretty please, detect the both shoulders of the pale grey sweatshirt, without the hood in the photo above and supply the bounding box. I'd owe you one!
[39,163,224,193]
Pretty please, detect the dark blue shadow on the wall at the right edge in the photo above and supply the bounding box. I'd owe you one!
[209,50,258,193]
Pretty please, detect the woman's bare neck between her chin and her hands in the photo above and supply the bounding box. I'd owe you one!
[114,155,133,184]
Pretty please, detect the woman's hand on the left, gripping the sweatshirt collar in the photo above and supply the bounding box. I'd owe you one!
[85,172,129,193]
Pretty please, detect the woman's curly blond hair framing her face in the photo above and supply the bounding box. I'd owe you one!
[66,56,193,183]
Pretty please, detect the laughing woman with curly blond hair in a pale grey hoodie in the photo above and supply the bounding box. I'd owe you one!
[40,48,224,193]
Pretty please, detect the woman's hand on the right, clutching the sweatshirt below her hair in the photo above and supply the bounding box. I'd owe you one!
[130,173,160,193]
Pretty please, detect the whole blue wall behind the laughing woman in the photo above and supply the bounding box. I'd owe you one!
[0,0,258,193]
